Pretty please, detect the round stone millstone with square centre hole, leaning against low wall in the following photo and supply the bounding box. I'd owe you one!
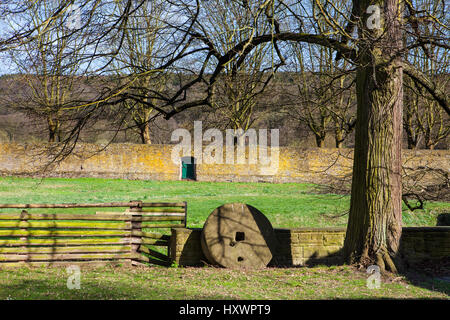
[201,203,277,269]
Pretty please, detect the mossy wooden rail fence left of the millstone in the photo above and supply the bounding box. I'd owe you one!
[0,201,187,268]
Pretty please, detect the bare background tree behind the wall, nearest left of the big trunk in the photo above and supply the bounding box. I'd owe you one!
[283,40,355,148]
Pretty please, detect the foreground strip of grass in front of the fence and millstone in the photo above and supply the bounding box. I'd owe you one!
[0,266,450,300]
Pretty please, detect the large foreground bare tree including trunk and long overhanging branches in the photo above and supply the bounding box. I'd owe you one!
[0,0,450,272]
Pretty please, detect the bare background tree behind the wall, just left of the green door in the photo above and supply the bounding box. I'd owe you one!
[115,1,168,144]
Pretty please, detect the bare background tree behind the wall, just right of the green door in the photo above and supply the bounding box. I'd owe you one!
[202,0,278,131]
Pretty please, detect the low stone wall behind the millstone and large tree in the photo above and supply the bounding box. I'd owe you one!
[169,227,450,266]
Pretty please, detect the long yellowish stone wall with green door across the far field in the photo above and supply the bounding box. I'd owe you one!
[0,144,450,183]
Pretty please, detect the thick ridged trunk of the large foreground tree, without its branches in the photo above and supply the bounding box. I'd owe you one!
[344,0,403,272]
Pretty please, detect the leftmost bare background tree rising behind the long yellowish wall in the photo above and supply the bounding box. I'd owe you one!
[4,0,83,142]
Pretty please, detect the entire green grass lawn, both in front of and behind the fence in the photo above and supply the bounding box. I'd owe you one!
[0,177,450,300]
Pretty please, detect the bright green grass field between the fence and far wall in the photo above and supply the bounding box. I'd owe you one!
[0,177,444,228]
